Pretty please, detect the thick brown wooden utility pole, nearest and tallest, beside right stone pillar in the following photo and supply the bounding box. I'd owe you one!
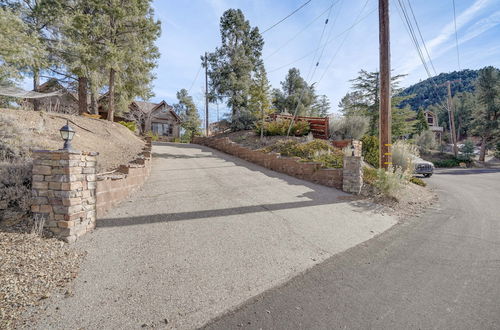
[378,0,392,169]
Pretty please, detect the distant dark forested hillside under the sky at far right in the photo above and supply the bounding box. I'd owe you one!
[399,69,479,110]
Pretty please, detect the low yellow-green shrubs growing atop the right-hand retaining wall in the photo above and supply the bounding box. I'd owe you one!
[265,140,344,168]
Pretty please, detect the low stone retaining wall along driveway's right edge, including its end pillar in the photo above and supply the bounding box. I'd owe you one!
[193,137,363,194]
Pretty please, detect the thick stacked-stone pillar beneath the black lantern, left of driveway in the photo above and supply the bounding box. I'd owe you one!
[31,150,98,243]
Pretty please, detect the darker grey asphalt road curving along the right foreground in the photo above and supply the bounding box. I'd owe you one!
[205,169,500,329]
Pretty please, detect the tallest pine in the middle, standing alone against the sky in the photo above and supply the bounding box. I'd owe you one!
[202,9,264,117]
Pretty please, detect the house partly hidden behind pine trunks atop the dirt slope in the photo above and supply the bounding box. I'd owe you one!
[26,78,78,114]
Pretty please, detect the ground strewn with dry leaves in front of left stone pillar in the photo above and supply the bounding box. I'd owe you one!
[0,232,83,329]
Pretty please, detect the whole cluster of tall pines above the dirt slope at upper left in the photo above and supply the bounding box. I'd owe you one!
[0,0,160,120]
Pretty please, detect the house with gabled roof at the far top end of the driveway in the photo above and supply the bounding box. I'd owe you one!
[129,101,181,140]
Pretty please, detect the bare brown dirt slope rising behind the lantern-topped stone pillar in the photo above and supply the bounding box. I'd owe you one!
[0,109,144,172]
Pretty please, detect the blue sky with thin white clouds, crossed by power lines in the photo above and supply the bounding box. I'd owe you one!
[153,0,500,121]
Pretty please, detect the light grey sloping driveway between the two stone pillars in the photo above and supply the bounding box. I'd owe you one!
[38,144,395,329]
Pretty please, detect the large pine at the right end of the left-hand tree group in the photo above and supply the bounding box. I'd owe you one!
[91,0,160,121]
